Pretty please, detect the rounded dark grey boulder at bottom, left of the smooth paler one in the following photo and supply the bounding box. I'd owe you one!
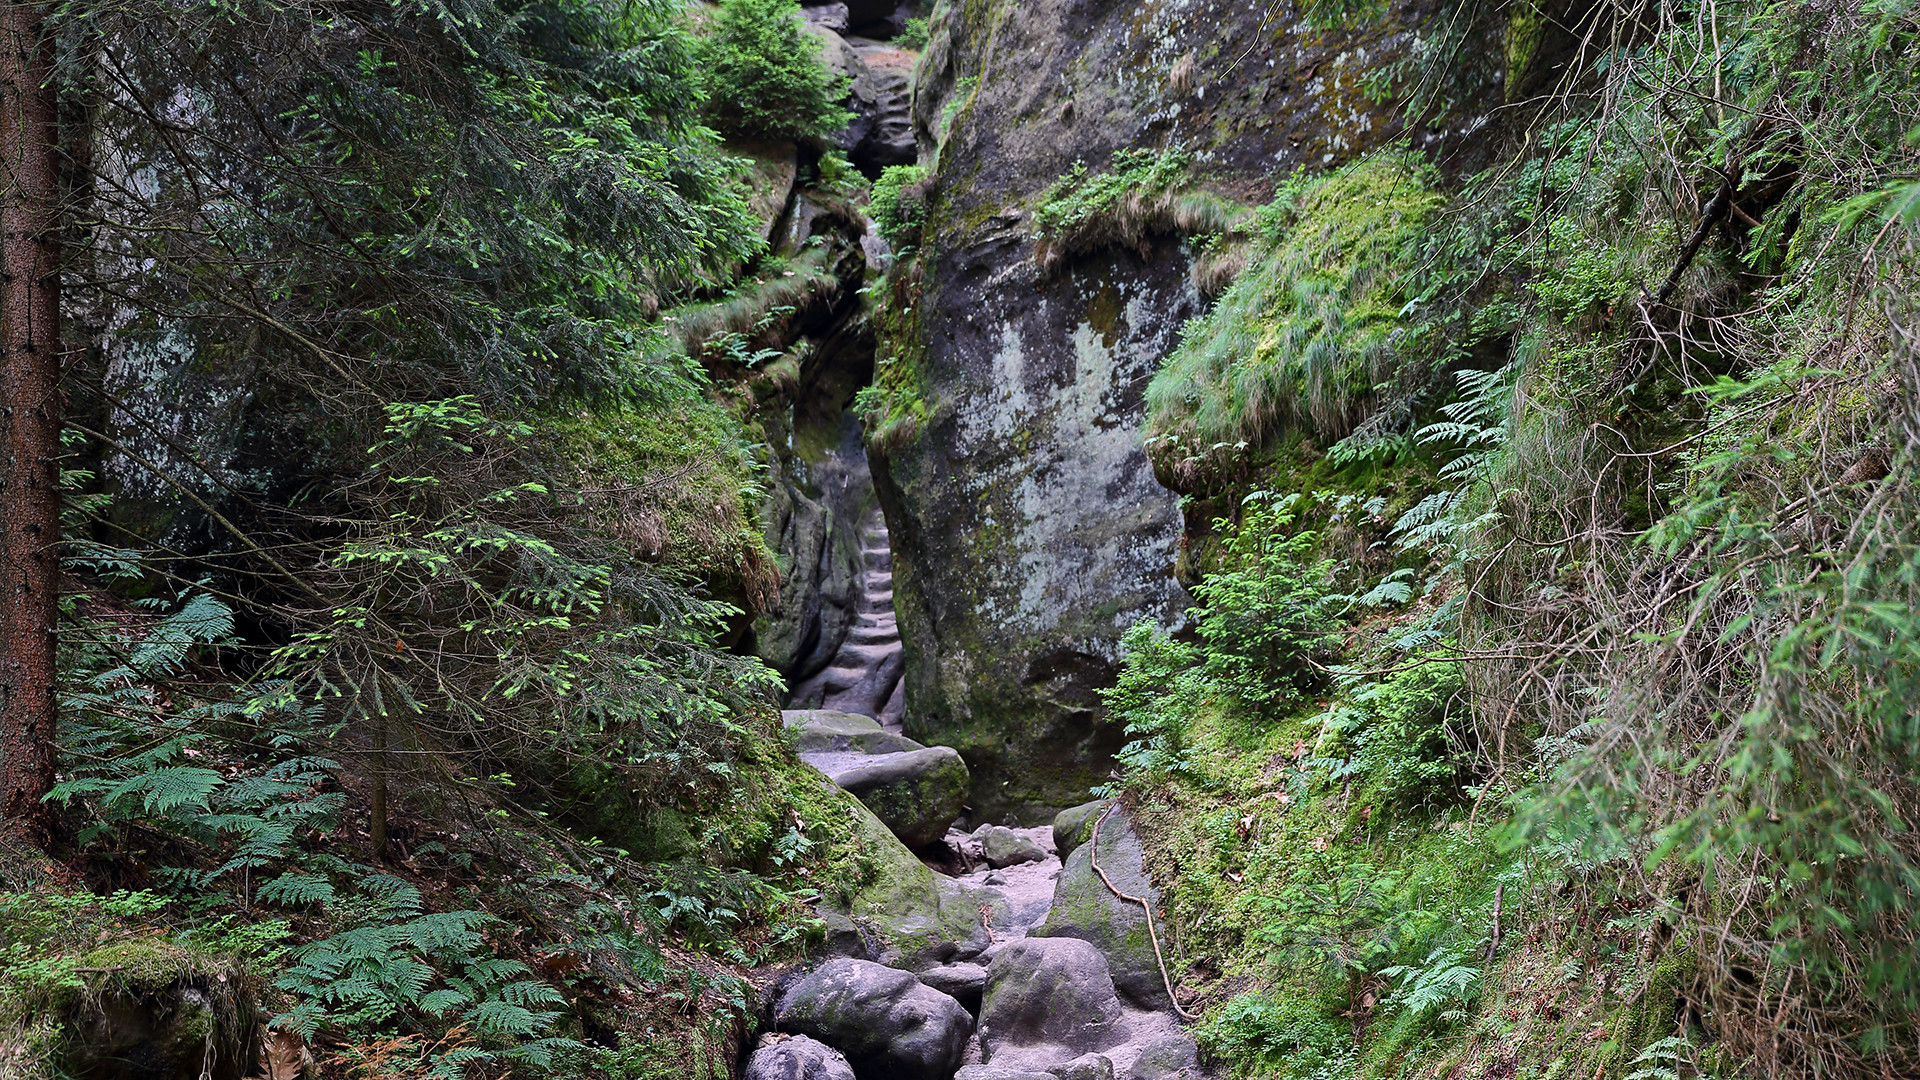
[774,959,973,1080]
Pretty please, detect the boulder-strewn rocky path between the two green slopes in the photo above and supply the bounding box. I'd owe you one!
[764,709,1204,1080]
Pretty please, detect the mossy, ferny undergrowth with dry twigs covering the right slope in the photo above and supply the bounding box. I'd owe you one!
[1110,4,1920,1078]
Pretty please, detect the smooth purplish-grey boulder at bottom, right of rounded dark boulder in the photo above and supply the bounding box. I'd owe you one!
[979,938,1121,1068]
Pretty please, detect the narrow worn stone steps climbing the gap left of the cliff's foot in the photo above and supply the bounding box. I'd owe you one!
[789,511,906,730]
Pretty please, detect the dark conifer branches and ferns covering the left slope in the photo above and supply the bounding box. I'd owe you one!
[0,0,876,1080]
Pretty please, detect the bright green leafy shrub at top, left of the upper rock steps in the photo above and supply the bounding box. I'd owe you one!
[701,0,849,144]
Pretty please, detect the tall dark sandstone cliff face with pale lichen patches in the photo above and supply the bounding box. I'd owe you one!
[874,0,1492,817]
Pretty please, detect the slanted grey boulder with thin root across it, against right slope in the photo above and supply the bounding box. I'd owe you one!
[1035,809,1171,1009]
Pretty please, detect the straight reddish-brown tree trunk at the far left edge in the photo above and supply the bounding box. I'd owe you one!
[0,4,60,846]
